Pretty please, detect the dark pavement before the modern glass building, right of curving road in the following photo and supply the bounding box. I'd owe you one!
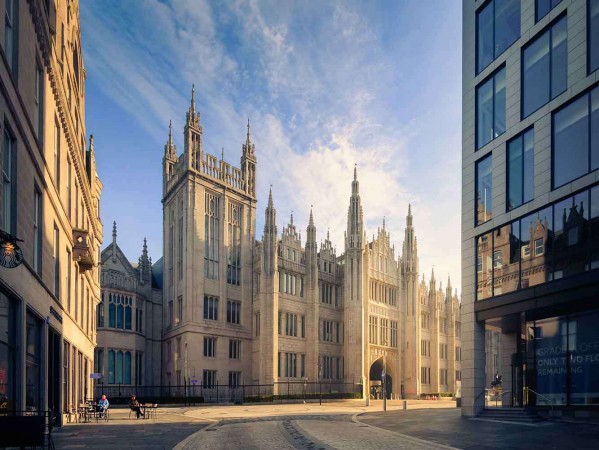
[357,408,599,450]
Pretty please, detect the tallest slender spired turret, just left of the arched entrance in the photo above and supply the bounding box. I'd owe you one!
[343,167,368,398]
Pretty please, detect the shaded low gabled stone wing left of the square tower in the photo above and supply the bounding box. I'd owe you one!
[94,223,163,395]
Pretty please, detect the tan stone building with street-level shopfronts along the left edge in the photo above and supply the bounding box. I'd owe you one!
[0,0,102,423]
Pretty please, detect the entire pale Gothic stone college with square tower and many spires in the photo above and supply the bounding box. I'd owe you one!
[94,91,461,400]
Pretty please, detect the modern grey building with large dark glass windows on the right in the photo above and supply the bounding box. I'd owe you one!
[462,0,599,417]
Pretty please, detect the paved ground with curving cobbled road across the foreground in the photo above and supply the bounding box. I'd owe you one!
[54,401,599,450]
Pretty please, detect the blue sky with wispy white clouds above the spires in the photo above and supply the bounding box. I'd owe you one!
[80,0,461,287]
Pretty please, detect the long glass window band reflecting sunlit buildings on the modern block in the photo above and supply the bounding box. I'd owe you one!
[476,186,599,300]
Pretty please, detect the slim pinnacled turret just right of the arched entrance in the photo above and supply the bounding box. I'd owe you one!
[401,205,421,398]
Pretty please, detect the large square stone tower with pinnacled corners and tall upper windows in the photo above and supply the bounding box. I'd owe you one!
[162,87,256,386]
